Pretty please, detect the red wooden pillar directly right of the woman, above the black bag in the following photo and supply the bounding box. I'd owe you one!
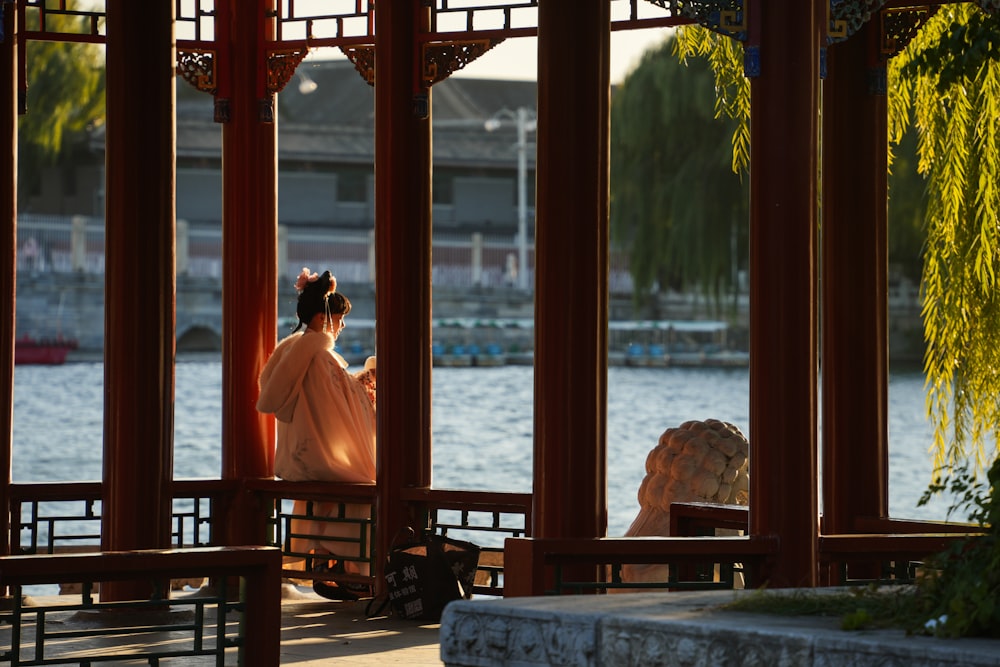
[375,0,432,586]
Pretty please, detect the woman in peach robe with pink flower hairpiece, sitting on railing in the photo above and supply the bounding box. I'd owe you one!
[257,268,375,599]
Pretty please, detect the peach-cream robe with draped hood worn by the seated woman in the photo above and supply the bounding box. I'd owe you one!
[257,330,375,573]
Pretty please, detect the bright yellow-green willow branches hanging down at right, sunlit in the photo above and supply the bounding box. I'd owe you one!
[677,0,1000,471]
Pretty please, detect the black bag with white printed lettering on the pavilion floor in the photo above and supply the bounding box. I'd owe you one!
[385,533,480,622]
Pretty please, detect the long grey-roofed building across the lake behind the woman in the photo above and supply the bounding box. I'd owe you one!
[22,60,536,238]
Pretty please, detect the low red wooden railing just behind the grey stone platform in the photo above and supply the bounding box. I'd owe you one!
[496,503,981,596]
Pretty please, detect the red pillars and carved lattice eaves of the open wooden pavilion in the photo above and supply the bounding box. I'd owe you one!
[0,0,994,660]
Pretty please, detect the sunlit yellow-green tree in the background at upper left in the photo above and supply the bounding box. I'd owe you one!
[18,13,105,209]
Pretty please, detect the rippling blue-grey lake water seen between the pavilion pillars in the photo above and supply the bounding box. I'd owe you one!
[13,360,965,535]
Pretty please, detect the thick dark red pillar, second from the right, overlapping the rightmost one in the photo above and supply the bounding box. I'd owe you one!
[747,0,826,587]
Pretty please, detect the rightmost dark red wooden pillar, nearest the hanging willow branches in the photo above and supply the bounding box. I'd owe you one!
[822,22,889,544]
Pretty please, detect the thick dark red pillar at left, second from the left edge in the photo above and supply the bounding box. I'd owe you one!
[101,0,176,600]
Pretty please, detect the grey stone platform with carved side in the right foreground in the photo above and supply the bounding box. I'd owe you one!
[440,591,1000,667]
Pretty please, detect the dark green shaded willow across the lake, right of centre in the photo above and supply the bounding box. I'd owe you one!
[611,39,748,318]
